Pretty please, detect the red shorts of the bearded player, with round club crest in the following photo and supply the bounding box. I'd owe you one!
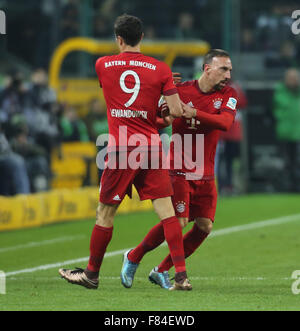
[171,175,217,222]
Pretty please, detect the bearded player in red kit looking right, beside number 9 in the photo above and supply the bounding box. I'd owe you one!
[128,49,237,289]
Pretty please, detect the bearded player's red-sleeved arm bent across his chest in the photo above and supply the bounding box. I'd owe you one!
[182,103,235,131]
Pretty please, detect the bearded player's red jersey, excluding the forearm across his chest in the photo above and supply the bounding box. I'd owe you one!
[170,80,237,180]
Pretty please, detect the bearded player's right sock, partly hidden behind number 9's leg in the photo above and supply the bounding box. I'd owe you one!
[158,224,209,272]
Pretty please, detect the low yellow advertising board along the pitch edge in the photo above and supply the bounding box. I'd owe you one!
[0,187,152,232]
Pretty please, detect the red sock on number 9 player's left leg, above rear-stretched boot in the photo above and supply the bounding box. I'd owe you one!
[87,224,113,275]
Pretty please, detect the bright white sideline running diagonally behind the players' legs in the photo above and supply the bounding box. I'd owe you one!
[6,214,300,277]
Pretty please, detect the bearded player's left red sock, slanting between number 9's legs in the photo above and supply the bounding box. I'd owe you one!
[128,223,165,263]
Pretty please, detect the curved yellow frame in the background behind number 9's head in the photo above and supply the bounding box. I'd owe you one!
[49,38,210,108]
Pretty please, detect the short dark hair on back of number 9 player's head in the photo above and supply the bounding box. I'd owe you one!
[114,14,143,47]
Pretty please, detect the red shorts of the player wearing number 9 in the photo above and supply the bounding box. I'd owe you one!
[100,151,173,204]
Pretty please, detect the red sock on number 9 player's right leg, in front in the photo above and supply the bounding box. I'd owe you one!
[162,216,186,273]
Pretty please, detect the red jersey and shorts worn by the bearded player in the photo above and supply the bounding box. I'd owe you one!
[170,80,237,221]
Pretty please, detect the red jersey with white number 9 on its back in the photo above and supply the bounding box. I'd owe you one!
[96,52,177,150]
